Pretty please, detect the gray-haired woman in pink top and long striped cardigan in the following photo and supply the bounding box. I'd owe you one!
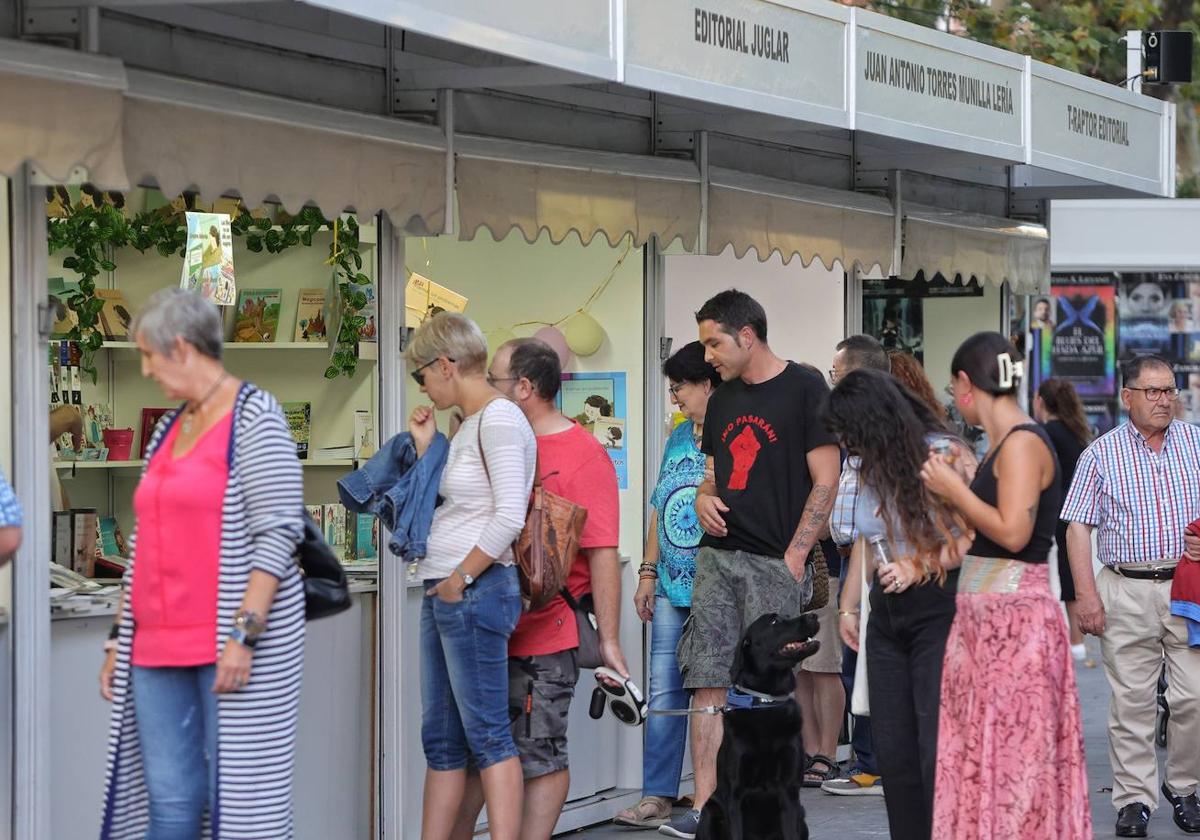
[100,289,305,840]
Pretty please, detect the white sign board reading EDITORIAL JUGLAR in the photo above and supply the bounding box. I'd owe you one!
[625,0,850,128]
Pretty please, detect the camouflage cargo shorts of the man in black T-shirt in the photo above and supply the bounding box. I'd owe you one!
[676,546,812,691]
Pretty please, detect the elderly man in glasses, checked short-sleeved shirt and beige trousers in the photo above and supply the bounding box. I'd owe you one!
[1062,356,1200,838]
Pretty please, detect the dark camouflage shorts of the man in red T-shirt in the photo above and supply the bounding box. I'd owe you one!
[509,648,580,779]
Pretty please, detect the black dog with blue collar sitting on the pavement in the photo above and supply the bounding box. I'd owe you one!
[696,613,820,840]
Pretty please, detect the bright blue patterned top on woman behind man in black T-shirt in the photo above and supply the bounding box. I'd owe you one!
[650,420,704,607]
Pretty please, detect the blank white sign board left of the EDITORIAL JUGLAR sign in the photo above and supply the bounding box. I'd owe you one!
[308,0,620,82]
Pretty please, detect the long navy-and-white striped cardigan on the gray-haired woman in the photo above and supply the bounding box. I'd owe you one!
[100,383,305,840]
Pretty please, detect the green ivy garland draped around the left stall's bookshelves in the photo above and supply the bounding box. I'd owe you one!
[47,193,371,382]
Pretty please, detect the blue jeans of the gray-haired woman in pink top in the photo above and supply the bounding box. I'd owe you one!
[133,665,217,840]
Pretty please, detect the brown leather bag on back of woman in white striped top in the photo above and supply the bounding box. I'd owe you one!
[478,400,588,612]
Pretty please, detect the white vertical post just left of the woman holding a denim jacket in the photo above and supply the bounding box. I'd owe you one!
[376,216,419,840]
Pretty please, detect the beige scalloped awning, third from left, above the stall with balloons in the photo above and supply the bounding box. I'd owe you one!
[456,138,700,248]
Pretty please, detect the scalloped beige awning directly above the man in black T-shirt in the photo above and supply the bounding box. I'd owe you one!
[708,167,895,271]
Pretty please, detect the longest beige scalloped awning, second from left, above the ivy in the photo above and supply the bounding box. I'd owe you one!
[124,71,446,229]
